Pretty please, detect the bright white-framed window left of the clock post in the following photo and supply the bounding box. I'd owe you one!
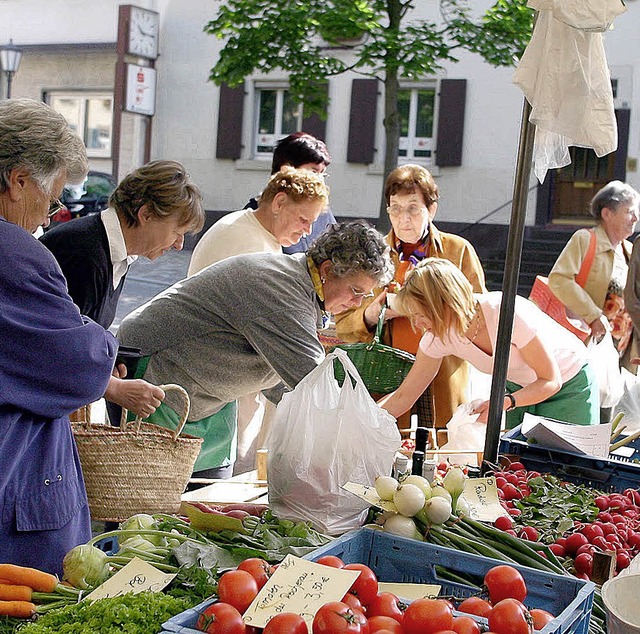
[48,92,113,157]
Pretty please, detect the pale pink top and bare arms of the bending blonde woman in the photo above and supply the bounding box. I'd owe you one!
[420,292,588,387]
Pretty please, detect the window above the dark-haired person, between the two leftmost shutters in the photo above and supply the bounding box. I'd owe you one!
[254,87,302,159]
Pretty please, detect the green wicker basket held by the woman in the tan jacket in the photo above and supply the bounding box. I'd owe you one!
[333,308,416,394]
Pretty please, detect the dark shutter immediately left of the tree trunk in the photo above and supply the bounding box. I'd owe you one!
[347,79,378,163]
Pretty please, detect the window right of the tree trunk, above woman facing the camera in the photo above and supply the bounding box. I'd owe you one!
[398,87,436,166]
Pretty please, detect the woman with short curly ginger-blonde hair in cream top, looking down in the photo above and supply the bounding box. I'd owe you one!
[189,165,330,473]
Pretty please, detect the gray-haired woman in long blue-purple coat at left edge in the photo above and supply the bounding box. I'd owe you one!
[0,99,117,574]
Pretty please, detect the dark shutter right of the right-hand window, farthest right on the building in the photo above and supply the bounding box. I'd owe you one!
[436,79,467,167]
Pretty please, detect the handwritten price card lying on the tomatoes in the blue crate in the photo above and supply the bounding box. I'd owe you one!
[242,555,360,631]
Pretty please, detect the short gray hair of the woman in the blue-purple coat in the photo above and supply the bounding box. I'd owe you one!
[0,99,89,193]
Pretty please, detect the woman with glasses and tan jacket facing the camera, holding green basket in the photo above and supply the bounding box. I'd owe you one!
[336,165,485,428]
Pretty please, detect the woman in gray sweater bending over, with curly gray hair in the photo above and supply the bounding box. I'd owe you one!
[118,222,391,477]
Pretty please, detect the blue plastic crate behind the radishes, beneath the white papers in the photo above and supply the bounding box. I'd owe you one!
[499,426,640,493]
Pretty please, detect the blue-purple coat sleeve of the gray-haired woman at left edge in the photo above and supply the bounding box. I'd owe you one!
[0,235,117,419]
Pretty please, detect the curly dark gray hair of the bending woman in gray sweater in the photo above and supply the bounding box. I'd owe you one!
[307,220,393,286]
